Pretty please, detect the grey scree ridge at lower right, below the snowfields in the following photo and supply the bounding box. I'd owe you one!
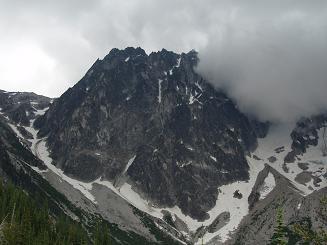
[232,168,327,245]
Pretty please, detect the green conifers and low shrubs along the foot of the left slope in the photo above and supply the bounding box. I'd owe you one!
[0,179,184,245]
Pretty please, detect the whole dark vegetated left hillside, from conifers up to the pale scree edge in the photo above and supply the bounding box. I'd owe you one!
[0,119,184,245]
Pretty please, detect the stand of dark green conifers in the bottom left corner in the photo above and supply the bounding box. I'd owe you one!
[0,180,111,245]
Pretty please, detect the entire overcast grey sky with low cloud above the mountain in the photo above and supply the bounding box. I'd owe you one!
[0,0,327,120]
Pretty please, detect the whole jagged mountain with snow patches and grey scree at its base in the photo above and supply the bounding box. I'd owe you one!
[0,48,327,244]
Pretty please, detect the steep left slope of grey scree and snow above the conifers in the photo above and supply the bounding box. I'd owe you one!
[0,91,179,244]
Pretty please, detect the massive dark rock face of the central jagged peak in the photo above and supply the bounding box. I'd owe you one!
[35,48,265,220]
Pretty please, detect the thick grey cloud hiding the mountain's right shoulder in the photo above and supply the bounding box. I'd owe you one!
[198,1,327,121]
